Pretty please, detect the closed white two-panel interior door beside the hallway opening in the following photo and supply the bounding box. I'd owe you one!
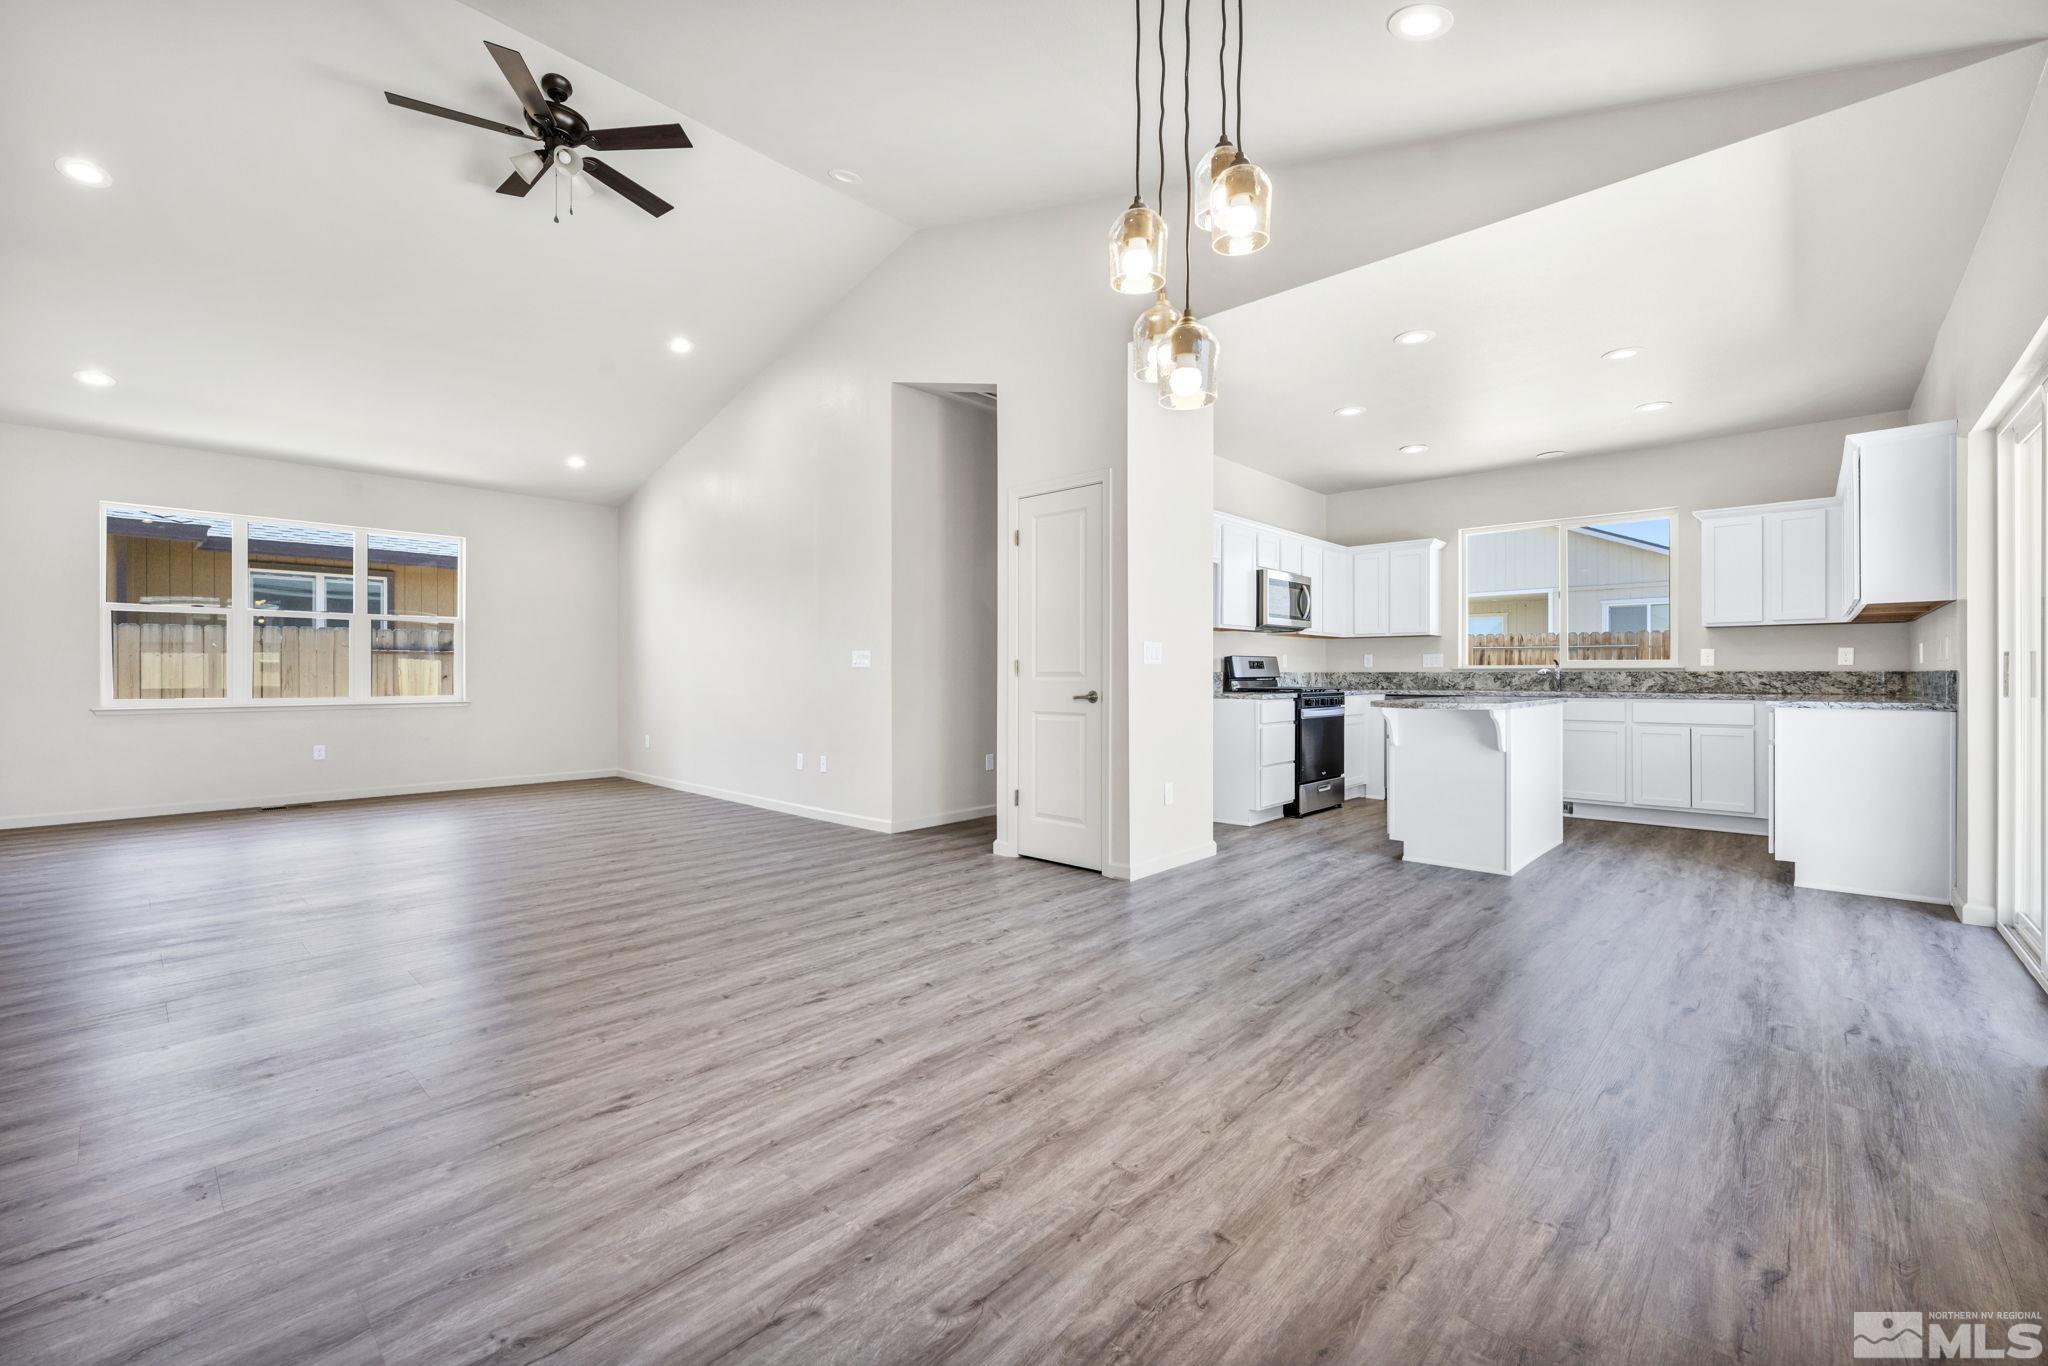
[1014,483,1105,870]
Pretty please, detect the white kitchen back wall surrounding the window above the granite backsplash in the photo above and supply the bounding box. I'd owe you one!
[1327,414,1907,670]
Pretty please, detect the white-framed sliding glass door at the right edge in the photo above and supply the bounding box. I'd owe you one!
[1999,389,2048,965]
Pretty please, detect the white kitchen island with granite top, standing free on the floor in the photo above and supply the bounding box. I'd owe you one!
[1378,694,1565,874]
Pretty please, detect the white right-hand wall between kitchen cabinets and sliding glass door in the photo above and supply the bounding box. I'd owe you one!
[1911,58,2048,924]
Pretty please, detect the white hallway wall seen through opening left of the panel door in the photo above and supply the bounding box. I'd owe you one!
[891,385,1001,829]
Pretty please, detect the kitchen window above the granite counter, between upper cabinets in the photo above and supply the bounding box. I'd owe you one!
[1460,512,1671,668]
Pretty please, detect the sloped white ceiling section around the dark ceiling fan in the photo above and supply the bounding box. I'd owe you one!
[0,0,903,500]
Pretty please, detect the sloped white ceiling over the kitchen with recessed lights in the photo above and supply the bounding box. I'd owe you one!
[1208,47,2044,492]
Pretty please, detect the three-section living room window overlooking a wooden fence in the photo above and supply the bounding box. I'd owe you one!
[100,504,463,707]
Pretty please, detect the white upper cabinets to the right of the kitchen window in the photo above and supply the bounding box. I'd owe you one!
[1694,422,1956,627]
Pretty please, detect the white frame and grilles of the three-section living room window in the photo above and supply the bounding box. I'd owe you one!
[92,500,469,711]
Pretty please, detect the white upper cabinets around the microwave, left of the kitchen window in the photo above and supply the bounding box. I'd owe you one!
[1210,512,1444,637]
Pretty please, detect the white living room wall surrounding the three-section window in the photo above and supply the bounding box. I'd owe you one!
[0,424,618,825]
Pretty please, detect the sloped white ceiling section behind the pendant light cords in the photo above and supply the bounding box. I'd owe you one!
[471,0,2048,225]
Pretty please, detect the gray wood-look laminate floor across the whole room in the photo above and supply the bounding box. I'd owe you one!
[0,782,2048,1366]
